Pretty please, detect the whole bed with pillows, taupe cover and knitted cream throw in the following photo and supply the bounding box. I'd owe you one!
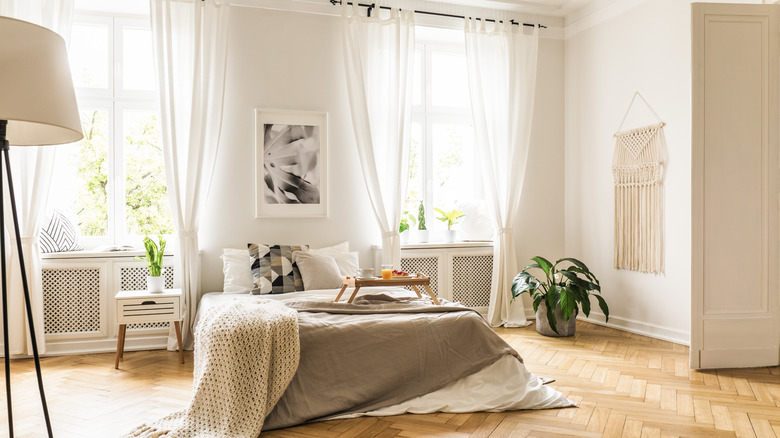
[123,242,575,438]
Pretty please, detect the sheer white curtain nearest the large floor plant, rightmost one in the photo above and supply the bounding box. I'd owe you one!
[466,19,539,327]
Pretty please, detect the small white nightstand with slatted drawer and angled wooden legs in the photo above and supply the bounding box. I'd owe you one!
[114,289,184,369]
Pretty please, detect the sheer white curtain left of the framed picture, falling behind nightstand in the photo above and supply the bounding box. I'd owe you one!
[151,0,230,350]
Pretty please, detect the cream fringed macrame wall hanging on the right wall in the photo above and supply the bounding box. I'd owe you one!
[612,92,666,274]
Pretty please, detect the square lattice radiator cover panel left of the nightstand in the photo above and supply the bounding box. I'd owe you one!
[42,268,100,333]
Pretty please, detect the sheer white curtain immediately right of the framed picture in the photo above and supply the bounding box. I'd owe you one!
[342,1,414,268]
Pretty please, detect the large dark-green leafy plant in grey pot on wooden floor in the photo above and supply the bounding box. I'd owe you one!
[512,256,609,333]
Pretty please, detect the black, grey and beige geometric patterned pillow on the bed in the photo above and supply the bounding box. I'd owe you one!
[247,243,309,295]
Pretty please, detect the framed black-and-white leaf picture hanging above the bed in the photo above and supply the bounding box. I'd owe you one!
[255,109,328,218]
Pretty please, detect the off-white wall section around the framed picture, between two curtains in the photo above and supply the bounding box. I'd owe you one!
[199,7,378,292]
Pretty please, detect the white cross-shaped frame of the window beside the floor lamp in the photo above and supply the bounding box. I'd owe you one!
[73,11,168,249]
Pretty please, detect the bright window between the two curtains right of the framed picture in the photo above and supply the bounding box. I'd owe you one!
[403,27,482,229]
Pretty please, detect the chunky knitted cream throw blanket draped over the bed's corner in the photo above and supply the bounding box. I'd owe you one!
[126,300,300,438]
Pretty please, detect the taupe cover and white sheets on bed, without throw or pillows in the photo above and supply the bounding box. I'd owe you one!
[194,288,574,430]
